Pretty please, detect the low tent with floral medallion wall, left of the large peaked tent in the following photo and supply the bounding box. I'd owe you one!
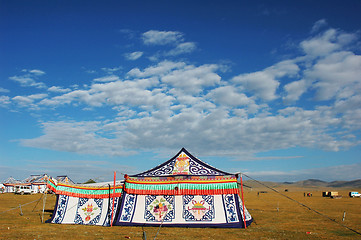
[48,178,123,226]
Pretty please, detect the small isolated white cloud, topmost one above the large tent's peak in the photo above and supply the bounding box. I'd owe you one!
[142,30,183,45]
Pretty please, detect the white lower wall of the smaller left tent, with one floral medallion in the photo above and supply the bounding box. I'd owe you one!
[51,195,120,226]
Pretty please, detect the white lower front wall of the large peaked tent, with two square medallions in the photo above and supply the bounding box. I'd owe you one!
[114,193,252,228]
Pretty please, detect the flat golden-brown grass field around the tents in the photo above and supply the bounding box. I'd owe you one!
[0,186,361,240]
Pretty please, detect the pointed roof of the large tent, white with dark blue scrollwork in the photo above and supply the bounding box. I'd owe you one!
[131,148,233,177]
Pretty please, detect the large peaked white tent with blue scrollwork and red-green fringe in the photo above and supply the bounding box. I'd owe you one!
[114,148,252,228]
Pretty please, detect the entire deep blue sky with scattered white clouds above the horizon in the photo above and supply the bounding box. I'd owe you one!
[0,0,361,182]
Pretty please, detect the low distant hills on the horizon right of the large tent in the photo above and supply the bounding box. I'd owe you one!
[244,179,361,188]
